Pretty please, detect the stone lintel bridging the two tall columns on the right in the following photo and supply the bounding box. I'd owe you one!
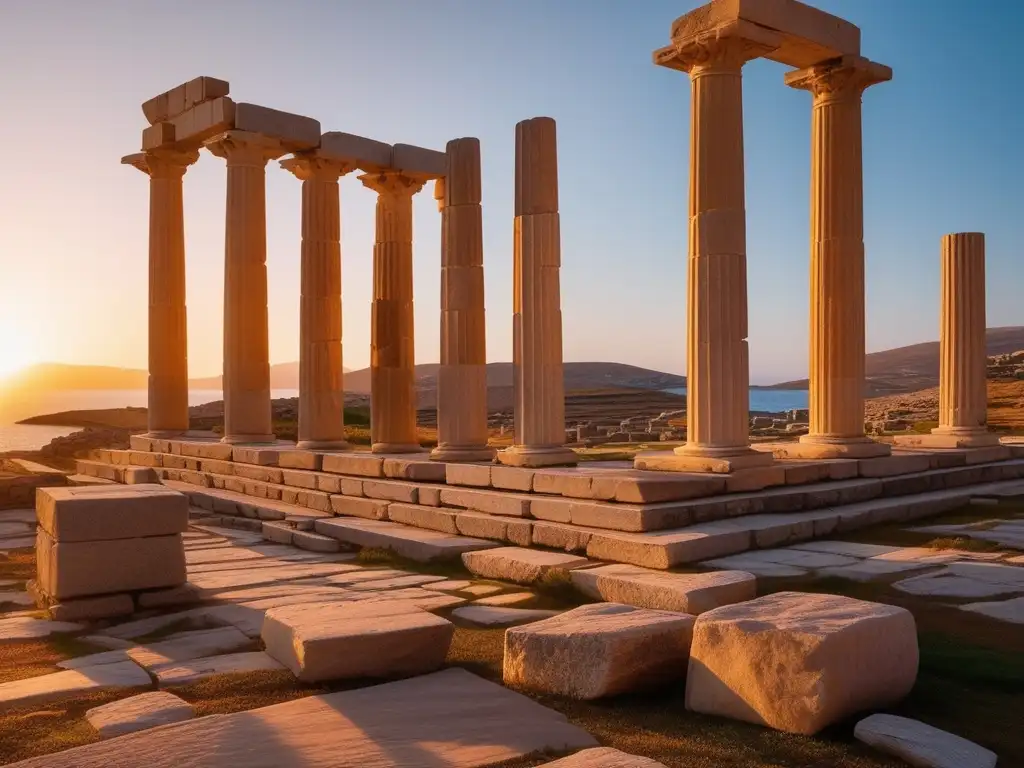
[672,0,860,68]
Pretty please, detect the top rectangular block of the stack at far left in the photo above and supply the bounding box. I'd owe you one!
[36,485,188,542]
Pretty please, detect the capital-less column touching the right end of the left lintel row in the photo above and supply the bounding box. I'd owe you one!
[430,138,495,462]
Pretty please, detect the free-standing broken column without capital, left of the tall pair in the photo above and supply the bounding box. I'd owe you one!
[498,118,577,467]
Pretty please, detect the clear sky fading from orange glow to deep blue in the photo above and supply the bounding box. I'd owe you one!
[0,0,1024,383]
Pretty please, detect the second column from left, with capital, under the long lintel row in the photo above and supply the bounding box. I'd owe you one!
[206,131,286,442]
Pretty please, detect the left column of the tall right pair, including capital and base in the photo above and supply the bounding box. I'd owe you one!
[655,26,778,472]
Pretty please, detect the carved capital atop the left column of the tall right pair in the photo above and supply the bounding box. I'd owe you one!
[654,22,782,77]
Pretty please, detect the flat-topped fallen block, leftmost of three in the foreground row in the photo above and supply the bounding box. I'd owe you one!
[262,601,455,682]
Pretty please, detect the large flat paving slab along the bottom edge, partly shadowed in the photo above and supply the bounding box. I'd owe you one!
[8,669,597,768]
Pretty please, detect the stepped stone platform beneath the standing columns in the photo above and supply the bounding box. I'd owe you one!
[78,435,1024,568]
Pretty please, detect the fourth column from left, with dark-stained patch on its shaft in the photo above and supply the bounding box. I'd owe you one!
[359,171,425,454]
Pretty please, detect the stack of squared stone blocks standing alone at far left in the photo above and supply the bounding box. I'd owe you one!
[33,484,188,621]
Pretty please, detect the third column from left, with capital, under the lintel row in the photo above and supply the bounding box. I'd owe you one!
[281,153,353,451]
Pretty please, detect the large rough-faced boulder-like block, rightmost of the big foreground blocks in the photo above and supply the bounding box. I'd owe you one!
[686,592,918,735]
